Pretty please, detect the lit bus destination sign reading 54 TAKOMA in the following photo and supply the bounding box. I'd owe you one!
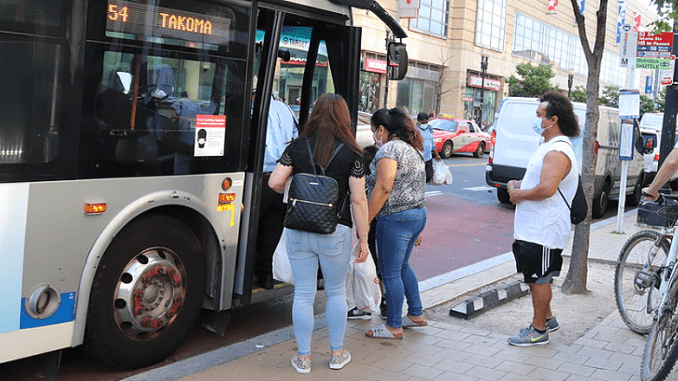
[106,0,231,44]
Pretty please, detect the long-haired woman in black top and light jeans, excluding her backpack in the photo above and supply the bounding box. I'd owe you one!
[268,94,369,373]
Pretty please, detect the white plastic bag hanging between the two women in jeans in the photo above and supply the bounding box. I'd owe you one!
[346,243,381,313]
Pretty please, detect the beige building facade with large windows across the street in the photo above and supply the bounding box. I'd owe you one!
[353,0,656,125]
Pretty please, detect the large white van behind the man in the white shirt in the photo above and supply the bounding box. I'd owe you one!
[485,97,645,218]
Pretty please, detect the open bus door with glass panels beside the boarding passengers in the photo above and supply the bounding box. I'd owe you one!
[235,3,361,304]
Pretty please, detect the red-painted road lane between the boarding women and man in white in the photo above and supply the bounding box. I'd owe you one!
[410,194,513,281]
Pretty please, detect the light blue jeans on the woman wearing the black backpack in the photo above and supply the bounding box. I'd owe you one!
[285,224,352,356]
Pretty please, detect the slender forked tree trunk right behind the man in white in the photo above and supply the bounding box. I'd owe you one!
[562,0,612,294]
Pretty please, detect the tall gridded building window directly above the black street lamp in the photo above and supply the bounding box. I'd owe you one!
[475,0,507,52]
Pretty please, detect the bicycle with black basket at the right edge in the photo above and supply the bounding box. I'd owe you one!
[615,194,678,381]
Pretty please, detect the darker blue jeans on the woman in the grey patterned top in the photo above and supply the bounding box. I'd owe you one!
[376,207,426,328]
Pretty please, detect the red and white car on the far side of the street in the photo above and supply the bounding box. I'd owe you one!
[436,115,492,159]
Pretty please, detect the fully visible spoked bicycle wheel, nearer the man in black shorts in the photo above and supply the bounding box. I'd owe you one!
[614,230,670,335]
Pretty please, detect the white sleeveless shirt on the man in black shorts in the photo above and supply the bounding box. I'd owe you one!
[513,136,579,249]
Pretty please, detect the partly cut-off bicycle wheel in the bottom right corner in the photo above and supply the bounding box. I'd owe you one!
[640,278,678,381]
